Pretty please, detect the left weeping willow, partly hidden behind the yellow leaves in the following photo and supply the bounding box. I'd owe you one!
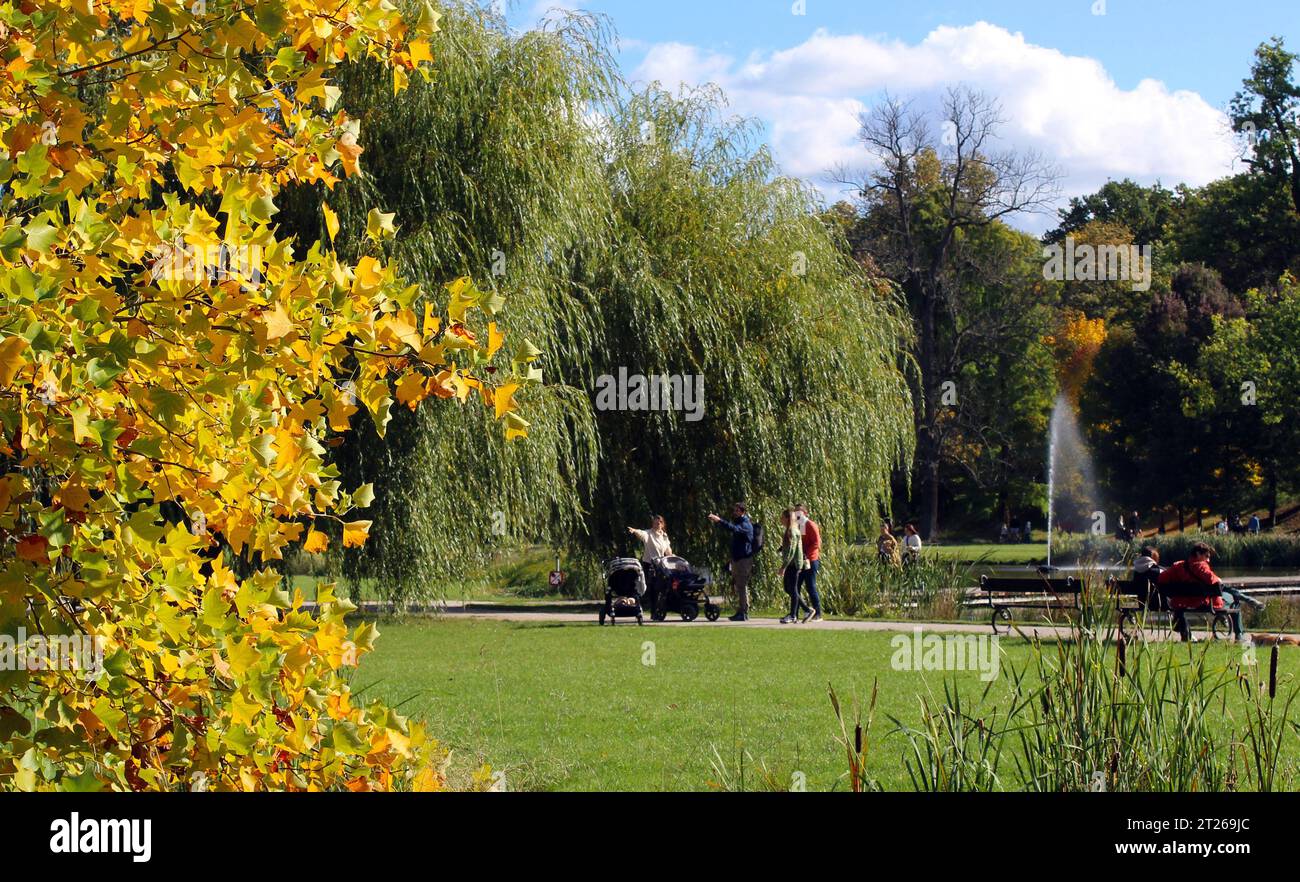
[276,5,615,598]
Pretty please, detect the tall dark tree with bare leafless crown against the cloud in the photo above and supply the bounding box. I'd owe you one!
[833,87,1060,536]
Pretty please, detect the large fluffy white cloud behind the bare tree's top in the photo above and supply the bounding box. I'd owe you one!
[633,22,1236,229]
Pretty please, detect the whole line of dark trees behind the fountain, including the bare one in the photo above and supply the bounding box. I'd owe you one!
[826,39,1300,533]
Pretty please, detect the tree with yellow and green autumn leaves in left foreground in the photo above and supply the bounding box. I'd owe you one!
[0,0,538,790]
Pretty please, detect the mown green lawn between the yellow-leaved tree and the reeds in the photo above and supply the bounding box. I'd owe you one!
[354,619,1297,791]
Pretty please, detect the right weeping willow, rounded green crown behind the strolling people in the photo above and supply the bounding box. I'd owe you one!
[588,87,913,572]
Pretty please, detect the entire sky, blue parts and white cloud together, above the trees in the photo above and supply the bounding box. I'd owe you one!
[510,0,1300,229]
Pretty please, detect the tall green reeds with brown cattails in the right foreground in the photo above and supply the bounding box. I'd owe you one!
[837,574,1297,792]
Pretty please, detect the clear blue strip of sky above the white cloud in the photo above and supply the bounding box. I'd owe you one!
[522,0,1300,105]
